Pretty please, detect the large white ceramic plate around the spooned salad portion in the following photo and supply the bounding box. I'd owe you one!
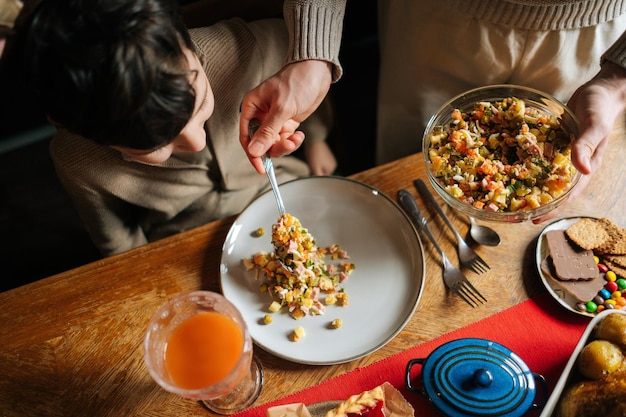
[220,177,425,365]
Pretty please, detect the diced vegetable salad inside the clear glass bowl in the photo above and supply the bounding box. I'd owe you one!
[428,97,576,212]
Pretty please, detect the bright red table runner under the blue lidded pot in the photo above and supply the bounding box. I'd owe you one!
[236,293,590,417]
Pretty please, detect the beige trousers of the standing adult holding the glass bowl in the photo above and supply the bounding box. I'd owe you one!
[376,0,626,164]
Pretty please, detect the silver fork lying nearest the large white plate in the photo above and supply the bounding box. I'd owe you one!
[398,190,487,307]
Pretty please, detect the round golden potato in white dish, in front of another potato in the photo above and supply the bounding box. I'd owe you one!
[577,340,624,379]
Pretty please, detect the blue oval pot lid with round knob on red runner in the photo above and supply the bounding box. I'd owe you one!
[422,338,536,417]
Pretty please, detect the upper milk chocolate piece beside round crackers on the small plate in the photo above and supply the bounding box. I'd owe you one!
[545,230,598,281]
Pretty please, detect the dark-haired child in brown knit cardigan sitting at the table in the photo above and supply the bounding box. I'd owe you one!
[23,0,341,256]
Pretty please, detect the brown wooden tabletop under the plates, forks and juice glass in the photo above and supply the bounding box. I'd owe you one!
[0,121,626,417]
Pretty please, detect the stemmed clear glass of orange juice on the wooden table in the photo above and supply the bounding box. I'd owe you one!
[144,291,263,415]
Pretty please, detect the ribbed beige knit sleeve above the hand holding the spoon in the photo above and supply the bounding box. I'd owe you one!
[283,0,346,82]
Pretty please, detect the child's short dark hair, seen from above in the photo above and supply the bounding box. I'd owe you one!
[24,0,195,150]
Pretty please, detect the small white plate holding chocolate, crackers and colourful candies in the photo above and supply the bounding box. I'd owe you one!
[536,217,626,317]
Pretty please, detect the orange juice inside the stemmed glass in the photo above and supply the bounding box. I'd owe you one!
[165,312,244,389]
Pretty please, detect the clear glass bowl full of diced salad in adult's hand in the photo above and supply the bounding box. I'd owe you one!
[422,84,581,223]
